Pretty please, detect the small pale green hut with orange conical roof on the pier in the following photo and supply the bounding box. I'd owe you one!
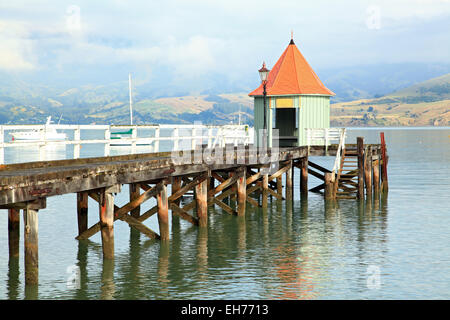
[249,39,334,147]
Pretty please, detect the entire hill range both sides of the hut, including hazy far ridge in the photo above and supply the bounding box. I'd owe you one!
[0,65,450,126]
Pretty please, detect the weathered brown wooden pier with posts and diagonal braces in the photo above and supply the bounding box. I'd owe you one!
[0,132,388,285]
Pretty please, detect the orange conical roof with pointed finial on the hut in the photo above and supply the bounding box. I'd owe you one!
[249,40,334,96]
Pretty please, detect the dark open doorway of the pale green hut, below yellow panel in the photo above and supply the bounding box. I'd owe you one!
[275,108,297,147]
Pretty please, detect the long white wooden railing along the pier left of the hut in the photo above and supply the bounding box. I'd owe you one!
[0,124,253,164]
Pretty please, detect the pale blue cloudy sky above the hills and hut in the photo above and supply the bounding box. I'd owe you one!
[0,0,450,89]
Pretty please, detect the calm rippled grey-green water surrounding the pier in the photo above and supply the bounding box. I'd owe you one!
[0,128,450,299]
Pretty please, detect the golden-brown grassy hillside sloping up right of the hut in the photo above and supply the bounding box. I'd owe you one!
[331,74,450,126]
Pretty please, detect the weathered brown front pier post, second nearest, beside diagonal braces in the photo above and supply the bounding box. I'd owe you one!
[99,185,120,259]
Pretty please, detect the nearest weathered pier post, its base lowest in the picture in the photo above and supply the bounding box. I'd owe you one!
[23,198,46,285]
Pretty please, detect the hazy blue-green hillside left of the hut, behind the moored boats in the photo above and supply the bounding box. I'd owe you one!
[0,87,253,125]
